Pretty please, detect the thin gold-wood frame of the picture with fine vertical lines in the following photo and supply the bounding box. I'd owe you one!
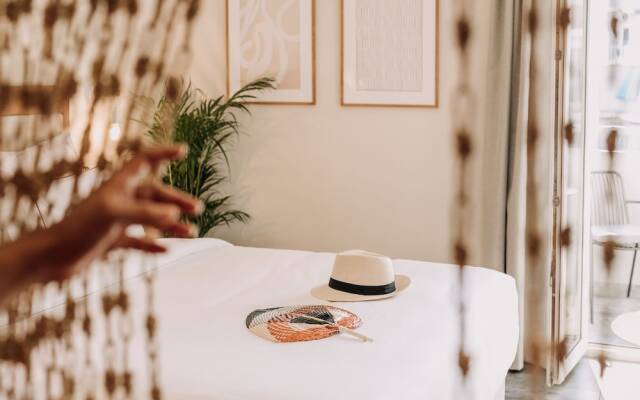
[340,0,440,108]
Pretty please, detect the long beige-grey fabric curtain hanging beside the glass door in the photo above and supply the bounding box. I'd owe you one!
[480,0,555,369]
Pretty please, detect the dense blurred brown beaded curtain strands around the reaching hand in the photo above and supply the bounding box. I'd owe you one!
[0,0,199,400]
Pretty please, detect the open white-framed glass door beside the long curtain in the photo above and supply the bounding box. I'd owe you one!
[550,0,588,384]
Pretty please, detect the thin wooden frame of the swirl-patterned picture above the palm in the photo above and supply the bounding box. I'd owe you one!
[225,0,316,105]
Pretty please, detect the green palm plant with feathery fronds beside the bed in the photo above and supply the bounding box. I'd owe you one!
[147,78,274,237]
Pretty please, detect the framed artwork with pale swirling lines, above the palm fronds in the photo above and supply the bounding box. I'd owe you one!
[227,0,315,104]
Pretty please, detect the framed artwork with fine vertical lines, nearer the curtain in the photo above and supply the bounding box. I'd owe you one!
[342,0,440,107]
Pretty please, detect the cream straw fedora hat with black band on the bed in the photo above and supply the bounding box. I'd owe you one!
[311,250,411,301]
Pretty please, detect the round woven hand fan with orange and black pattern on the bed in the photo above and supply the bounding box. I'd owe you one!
[246,305,372,343]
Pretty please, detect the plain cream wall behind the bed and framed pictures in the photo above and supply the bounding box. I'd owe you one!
[191,0,498,264]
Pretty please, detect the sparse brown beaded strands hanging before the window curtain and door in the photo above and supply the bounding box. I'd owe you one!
[452,0,619,398]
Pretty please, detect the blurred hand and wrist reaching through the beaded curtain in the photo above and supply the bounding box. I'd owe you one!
[14,146,202,282]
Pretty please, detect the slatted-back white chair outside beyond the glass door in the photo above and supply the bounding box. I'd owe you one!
[591,171,640,322]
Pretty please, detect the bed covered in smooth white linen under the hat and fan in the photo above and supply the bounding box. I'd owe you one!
[141,241,518,400]
